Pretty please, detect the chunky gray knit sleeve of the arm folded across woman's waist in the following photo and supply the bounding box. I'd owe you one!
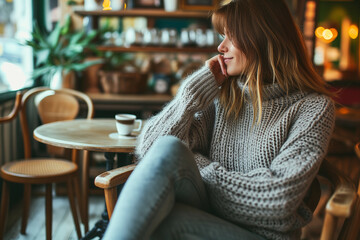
[201,98,334,232]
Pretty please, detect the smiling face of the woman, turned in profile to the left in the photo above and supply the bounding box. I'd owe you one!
[218,34,246,76]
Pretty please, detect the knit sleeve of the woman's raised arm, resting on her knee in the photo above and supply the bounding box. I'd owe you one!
[136,67,219,159]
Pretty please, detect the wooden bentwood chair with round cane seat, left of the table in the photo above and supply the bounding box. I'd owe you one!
[0,87,94,239]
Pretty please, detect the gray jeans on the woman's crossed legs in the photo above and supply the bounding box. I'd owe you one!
[103,136,263,240]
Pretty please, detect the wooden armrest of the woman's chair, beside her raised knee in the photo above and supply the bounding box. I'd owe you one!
[95,164,136,189]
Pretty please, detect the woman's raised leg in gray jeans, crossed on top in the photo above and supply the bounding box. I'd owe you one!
[103,136,208,240]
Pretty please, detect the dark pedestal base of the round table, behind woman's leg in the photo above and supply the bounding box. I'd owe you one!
[81,153,132,240]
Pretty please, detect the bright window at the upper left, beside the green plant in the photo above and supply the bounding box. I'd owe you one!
[0,0,33,94]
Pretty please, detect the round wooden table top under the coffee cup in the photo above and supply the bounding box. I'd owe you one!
[34,119,139,153]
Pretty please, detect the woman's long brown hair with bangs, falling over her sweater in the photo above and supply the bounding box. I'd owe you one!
[212,0,332,122]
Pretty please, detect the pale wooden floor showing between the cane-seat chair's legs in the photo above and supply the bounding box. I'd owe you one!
[4,195,104,240]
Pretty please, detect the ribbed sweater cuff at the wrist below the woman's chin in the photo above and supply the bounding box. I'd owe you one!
[178,66,219,110]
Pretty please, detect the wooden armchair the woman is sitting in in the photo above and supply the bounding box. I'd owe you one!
[95,160,359,240]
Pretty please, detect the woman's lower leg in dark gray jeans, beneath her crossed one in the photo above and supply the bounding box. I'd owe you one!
[151,203,264,240]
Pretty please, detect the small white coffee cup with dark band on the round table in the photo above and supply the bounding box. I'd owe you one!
[115,113,142,136]
